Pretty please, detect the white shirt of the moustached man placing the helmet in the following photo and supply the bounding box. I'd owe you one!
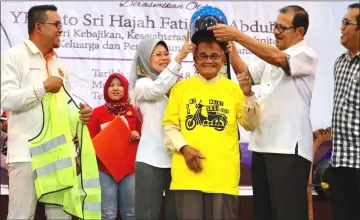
[248,41,317,161]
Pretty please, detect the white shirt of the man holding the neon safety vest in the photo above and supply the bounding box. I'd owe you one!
[1,40,70,163]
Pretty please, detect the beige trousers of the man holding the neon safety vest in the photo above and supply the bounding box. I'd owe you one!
[7,162,71,220]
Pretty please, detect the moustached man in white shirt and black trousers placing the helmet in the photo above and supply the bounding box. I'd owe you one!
[209,5,317,220]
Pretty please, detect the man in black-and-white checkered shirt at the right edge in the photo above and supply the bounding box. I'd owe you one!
[330,3,360,220]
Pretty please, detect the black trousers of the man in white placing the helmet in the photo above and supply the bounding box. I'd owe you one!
[251,152,311,220]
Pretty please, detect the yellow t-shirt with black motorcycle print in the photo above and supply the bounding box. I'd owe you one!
[163,76,248,195]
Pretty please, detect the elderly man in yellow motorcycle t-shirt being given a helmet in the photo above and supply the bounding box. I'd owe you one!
[163,31,259,219]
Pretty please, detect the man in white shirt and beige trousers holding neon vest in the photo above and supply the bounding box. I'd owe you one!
[1,5,92,219]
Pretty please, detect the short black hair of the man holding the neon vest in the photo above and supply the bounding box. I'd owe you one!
[28,5,57,35]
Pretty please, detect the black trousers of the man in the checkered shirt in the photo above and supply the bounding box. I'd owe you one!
[330,167,360,220]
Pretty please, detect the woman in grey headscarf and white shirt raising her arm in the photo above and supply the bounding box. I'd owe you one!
[129,37,195,219]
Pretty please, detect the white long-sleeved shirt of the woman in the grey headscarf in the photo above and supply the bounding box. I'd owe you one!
[133,61,181,168]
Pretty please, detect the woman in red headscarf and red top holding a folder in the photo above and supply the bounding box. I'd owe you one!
[88,73,140,220]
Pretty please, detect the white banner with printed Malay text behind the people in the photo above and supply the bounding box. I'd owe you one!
[1,1,352,191]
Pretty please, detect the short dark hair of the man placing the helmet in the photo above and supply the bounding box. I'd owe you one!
[279,5,309,36]
